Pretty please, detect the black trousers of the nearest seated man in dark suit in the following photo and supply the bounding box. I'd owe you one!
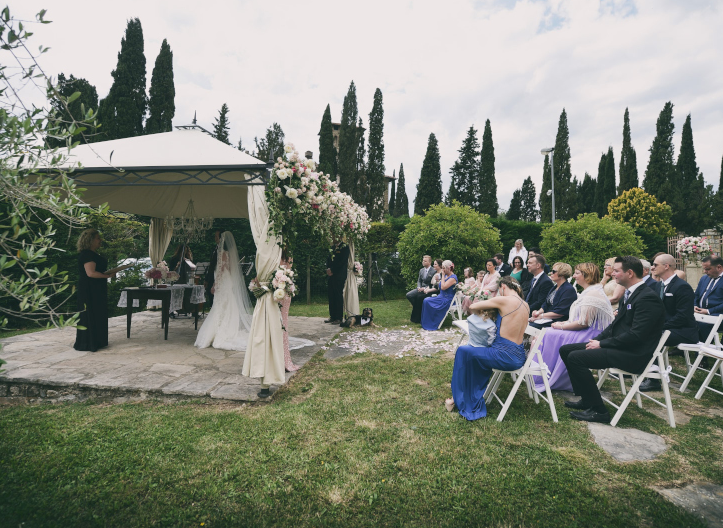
[560,343,652,413]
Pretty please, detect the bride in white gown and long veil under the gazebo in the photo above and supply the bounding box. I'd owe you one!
[195,231,314,350]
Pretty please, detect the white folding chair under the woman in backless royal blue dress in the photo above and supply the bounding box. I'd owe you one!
[484,326,557,422]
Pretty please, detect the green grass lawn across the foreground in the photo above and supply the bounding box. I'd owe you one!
[0,300,723,528]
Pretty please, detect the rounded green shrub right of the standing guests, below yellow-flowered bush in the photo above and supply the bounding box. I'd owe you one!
[540,213,645,269]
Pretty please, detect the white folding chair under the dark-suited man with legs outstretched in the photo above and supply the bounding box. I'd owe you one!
[597,330,675,427]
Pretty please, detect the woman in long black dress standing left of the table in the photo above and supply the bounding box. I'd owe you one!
[73,229,115,352]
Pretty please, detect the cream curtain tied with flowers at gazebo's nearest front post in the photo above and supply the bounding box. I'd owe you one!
[242,185,286,385]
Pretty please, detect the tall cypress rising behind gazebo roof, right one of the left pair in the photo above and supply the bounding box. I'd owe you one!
[146,39,176,134]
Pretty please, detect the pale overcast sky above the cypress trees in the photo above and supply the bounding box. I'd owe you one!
[9,0,723,216]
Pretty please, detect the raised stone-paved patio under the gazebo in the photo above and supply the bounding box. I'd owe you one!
[0,312,340,401]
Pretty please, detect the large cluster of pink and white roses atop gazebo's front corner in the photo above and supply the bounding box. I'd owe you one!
[266,144,369,253]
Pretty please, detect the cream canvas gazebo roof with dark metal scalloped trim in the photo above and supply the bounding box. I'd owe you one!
[63,128,267,218]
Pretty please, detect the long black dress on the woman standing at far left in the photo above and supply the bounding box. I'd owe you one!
[73,249,108,352]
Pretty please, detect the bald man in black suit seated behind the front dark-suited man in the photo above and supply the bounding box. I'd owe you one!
[640,254,698,391]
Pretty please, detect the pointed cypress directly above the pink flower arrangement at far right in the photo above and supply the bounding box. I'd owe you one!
[671,114,708,235]
